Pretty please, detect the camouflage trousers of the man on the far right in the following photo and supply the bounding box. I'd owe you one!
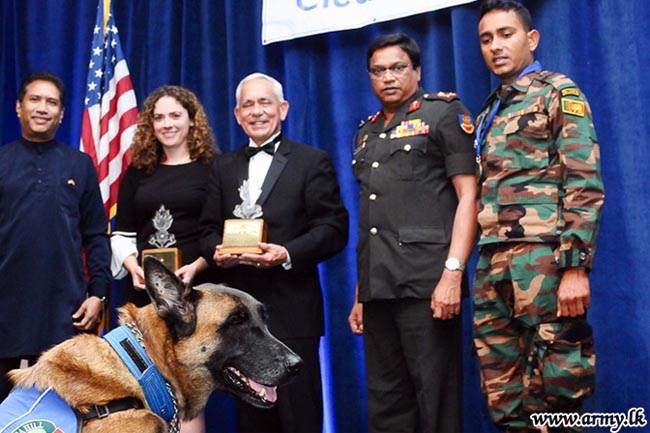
[473,243,596,432]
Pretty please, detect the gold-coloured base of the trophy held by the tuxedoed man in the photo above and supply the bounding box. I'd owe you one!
[219,218,267,254]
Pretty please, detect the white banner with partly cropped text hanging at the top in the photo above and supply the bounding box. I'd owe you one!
[262,0,475,45]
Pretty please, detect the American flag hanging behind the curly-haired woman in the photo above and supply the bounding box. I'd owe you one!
[79,0,138,220]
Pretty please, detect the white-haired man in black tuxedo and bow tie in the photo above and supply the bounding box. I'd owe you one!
[201,73,348,433]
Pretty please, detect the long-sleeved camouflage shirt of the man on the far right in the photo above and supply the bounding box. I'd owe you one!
[476,69,604,268]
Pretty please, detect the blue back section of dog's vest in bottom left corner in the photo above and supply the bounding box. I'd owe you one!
[0,387,81,433]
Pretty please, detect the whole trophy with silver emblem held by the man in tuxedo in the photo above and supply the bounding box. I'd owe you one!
[220,180,267,254]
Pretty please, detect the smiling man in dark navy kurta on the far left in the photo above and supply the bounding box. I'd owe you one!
[0,73,110,400]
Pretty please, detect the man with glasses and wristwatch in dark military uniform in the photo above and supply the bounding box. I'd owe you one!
[349,34,477,433]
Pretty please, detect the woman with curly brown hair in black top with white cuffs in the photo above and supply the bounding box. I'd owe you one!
[111,86,219,306]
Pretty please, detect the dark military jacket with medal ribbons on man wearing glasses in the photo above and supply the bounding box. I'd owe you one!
[352,89,475,302]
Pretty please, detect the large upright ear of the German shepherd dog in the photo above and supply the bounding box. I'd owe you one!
[144,256,196,340]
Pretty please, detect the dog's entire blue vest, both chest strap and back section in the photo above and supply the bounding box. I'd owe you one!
[0,325,178,433]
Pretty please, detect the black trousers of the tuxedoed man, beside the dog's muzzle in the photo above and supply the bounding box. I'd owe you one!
[237,337,323,433]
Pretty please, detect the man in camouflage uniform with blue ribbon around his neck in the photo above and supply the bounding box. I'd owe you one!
[474,0,604,432]
